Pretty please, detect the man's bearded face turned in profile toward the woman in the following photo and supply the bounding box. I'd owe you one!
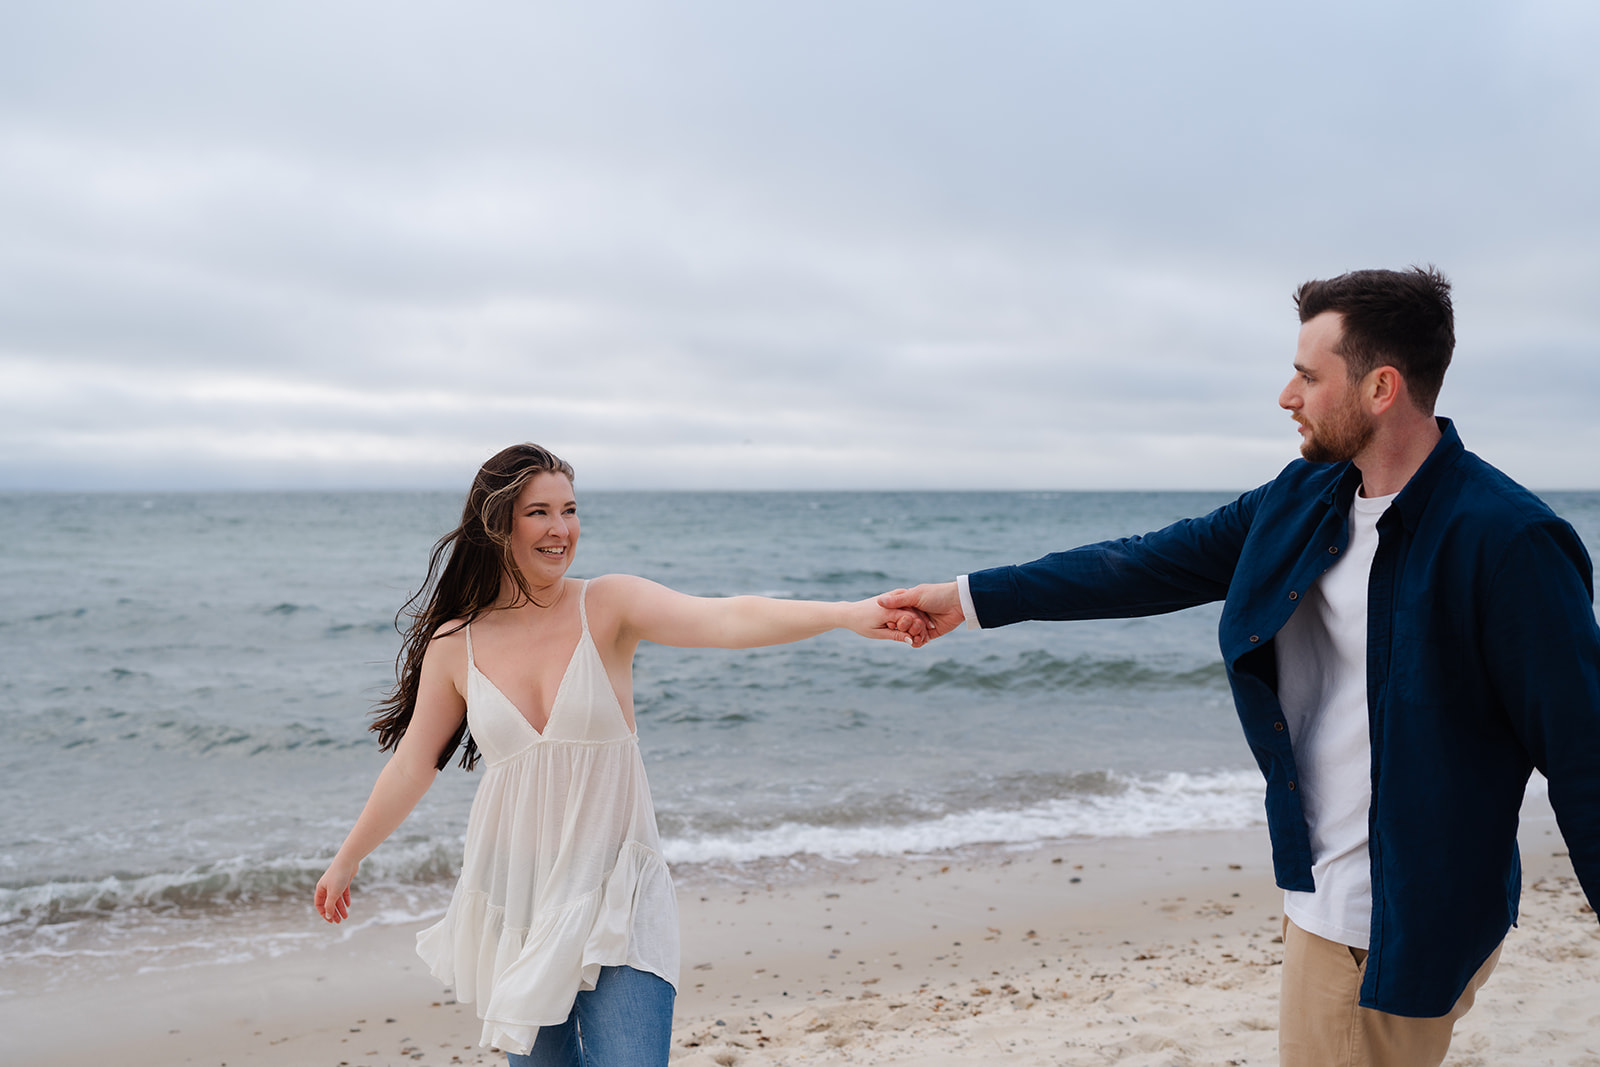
[1278,312,1373,462]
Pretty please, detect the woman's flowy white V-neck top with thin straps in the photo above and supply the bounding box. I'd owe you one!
[416,581,678,1054]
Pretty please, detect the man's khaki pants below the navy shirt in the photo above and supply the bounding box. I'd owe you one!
[1278,918,1504,1067]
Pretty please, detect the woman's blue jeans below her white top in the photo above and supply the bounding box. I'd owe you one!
[506,966,677,1067]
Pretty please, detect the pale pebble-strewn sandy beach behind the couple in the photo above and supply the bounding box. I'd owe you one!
[0,801,1600,1067]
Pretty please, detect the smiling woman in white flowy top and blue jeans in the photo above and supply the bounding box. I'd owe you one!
[315,445,925,1067]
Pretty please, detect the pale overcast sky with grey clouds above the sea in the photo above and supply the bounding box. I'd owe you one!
[0,0,1600,488]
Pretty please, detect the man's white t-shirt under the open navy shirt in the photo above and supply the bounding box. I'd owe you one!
[1275,494,1395,949]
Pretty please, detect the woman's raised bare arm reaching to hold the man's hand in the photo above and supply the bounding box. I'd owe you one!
[595,574,928,648]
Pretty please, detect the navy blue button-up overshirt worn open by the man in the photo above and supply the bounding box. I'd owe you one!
[968,419,1600,1016]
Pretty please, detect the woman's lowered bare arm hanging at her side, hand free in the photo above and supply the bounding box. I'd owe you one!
[315,624,467,923]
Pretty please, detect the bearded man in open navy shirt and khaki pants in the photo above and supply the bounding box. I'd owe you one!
[880,269,1600,1067]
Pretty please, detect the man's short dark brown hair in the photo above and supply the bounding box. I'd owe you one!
[1294,266,1456,414]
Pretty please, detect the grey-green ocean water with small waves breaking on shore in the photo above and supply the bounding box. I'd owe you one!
[0,485,1600,995]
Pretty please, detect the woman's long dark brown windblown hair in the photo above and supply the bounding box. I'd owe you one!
[368,445,573,771]
